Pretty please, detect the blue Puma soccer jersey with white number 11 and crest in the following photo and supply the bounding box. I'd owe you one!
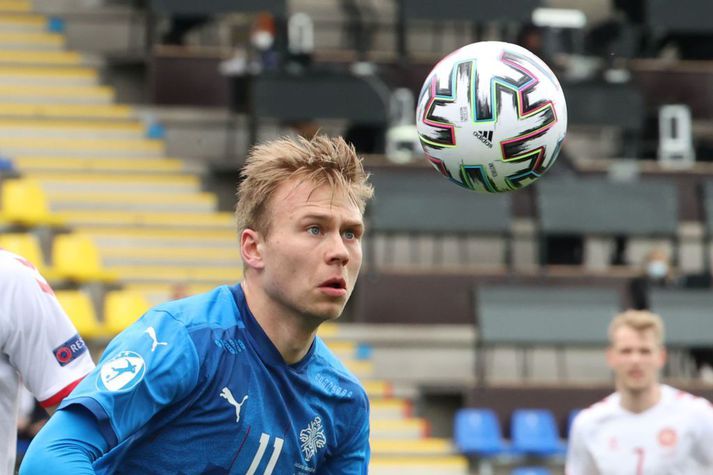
[60,285,369,475]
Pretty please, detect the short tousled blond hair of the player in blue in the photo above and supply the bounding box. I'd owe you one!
[235,135,374,234]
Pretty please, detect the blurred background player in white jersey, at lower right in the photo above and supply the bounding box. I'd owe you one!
[565,310,713,475]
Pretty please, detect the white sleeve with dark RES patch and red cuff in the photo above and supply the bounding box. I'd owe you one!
[0,254,94,406]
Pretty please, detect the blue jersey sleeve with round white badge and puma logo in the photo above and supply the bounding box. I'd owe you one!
[60,310,199,447]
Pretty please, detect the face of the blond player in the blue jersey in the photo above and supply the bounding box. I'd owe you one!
[260,178,364,321]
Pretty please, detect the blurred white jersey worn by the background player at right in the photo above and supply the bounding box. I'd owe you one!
[565,385,713,475]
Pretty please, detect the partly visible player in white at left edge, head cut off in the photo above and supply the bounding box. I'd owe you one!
[0,249,94,475]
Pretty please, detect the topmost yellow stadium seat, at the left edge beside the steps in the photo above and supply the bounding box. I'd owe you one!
[0,178,62,226]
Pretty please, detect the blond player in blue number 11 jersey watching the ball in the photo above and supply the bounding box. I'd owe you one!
[21,136,373,475]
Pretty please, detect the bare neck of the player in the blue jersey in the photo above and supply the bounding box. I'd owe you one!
[241,279,319,364]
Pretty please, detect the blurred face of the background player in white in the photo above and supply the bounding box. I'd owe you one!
[607,326,666,392]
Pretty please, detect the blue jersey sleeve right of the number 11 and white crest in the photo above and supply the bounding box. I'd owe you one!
[319,395,371,475]
